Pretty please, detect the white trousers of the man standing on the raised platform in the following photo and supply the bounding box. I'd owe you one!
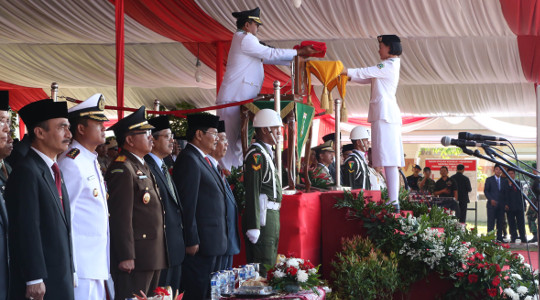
[217,103,244,170]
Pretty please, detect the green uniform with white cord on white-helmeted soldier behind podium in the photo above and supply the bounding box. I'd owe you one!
[341,150,371,190]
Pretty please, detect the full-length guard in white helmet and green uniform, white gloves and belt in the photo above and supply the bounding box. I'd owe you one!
[242,109,283,276]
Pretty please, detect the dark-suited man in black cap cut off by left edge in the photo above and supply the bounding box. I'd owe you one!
[0,91,13,300]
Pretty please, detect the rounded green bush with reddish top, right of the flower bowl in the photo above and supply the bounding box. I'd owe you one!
[332,236,399,300]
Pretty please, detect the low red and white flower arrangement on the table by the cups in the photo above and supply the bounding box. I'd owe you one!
[266,256,322,294]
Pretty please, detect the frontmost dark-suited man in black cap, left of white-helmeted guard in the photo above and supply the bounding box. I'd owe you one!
[173,114,227,300]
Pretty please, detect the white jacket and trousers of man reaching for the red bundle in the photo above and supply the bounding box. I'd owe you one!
[216,31,297,170]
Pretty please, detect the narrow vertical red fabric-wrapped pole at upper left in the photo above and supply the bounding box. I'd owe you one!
[115,0,124,119]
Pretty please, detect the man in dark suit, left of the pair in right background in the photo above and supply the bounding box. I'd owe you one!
[484,165,506,242]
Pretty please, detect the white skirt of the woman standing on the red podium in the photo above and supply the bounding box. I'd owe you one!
[371,120,405,167]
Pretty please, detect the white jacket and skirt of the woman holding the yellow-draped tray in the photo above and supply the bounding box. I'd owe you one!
[347,58,405,167]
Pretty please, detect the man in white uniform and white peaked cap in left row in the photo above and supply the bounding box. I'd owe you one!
[58,94,110,300]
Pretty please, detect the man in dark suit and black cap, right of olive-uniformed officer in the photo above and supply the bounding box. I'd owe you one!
[144,116,186,294]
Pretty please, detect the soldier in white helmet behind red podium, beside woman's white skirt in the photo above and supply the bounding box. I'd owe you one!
[341,126,371,190]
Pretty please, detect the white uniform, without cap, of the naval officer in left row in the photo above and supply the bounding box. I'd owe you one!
[58,140,110,300]
